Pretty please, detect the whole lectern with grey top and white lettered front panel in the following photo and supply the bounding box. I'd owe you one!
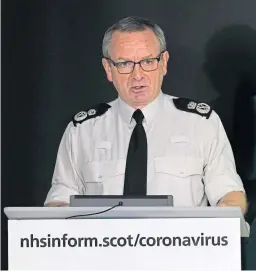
[4,206,249,271]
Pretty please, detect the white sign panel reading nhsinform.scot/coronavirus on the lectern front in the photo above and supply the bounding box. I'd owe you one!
[8,218,241,271]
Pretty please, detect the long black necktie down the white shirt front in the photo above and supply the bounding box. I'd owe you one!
[124,109,147,196]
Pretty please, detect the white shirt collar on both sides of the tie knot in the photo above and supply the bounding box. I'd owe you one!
[118,91,163,126]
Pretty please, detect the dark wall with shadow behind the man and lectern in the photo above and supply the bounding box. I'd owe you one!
[1,0,256,269]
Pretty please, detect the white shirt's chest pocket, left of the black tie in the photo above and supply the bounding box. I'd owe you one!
[82,159,126,195]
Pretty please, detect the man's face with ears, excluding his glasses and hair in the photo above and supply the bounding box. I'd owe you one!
[103,29,169,108]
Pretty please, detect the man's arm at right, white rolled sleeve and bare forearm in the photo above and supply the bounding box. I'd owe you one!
[204,111,247,214]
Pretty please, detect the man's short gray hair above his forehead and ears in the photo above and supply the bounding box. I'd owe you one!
[102,16,166,57]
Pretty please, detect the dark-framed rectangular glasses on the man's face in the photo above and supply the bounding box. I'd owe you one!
[106,52,164,74]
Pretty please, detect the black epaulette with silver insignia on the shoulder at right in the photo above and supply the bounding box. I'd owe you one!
[173,98,212,119]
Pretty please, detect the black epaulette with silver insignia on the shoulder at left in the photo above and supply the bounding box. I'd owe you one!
[72,103,111,126]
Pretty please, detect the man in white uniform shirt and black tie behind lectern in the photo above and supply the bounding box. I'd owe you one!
[45,17,247,213]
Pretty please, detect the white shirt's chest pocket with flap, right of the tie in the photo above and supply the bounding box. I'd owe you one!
[152,156,204,206]
